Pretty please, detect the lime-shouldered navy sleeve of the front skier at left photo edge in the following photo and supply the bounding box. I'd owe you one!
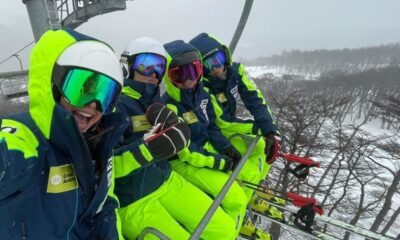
[0,120,41,200]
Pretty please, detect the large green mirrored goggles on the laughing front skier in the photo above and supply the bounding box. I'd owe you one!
[60,68,121,113]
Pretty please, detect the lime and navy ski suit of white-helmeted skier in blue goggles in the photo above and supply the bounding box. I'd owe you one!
[115,79,235,240]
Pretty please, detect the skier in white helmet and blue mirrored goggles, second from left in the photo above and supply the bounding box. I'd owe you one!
[115,37,235,239]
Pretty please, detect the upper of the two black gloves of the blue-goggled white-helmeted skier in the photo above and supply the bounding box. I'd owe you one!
[146,103,179,130]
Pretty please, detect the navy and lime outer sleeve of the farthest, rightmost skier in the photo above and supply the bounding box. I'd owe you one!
[237,64,279,135]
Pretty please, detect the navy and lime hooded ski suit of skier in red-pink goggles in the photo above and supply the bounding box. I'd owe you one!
[163,40,261,235]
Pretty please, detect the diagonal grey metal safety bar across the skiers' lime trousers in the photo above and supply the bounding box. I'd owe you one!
[190,136,260,240]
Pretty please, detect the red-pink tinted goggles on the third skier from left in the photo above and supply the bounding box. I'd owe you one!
[168,61,203,84]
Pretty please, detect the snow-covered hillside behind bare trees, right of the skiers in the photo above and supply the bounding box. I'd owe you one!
[246,66,400,239]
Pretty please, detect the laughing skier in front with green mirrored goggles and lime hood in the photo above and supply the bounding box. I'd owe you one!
[0,30,127,239]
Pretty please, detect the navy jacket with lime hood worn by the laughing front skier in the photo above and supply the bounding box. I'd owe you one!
[0,30,128,240]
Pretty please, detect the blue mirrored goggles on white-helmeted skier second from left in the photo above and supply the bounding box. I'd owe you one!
[132,53,167,80]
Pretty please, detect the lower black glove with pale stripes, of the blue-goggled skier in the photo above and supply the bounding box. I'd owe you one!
[143,120,190,160]
